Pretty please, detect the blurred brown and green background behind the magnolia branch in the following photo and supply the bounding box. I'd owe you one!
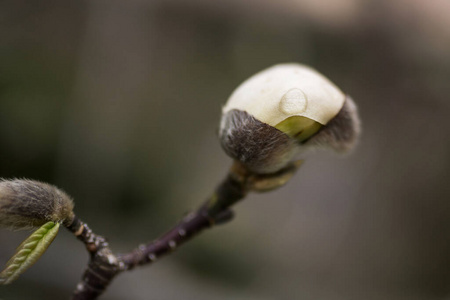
[0,0,450,300]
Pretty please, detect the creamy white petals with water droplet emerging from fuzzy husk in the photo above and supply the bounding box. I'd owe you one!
[223,64,345,126]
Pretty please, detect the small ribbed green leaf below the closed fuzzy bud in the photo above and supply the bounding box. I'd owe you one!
[0,222,59,284]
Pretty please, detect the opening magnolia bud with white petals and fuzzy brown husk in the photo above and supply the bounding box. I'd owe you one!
[219,64,359,174]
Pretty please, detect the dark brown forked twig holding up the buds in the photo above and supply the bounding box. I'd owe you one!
[66,163,251,300]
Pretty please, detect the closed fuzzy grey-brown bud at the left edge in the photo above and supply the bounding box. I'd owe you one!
[0,179,74,230]
